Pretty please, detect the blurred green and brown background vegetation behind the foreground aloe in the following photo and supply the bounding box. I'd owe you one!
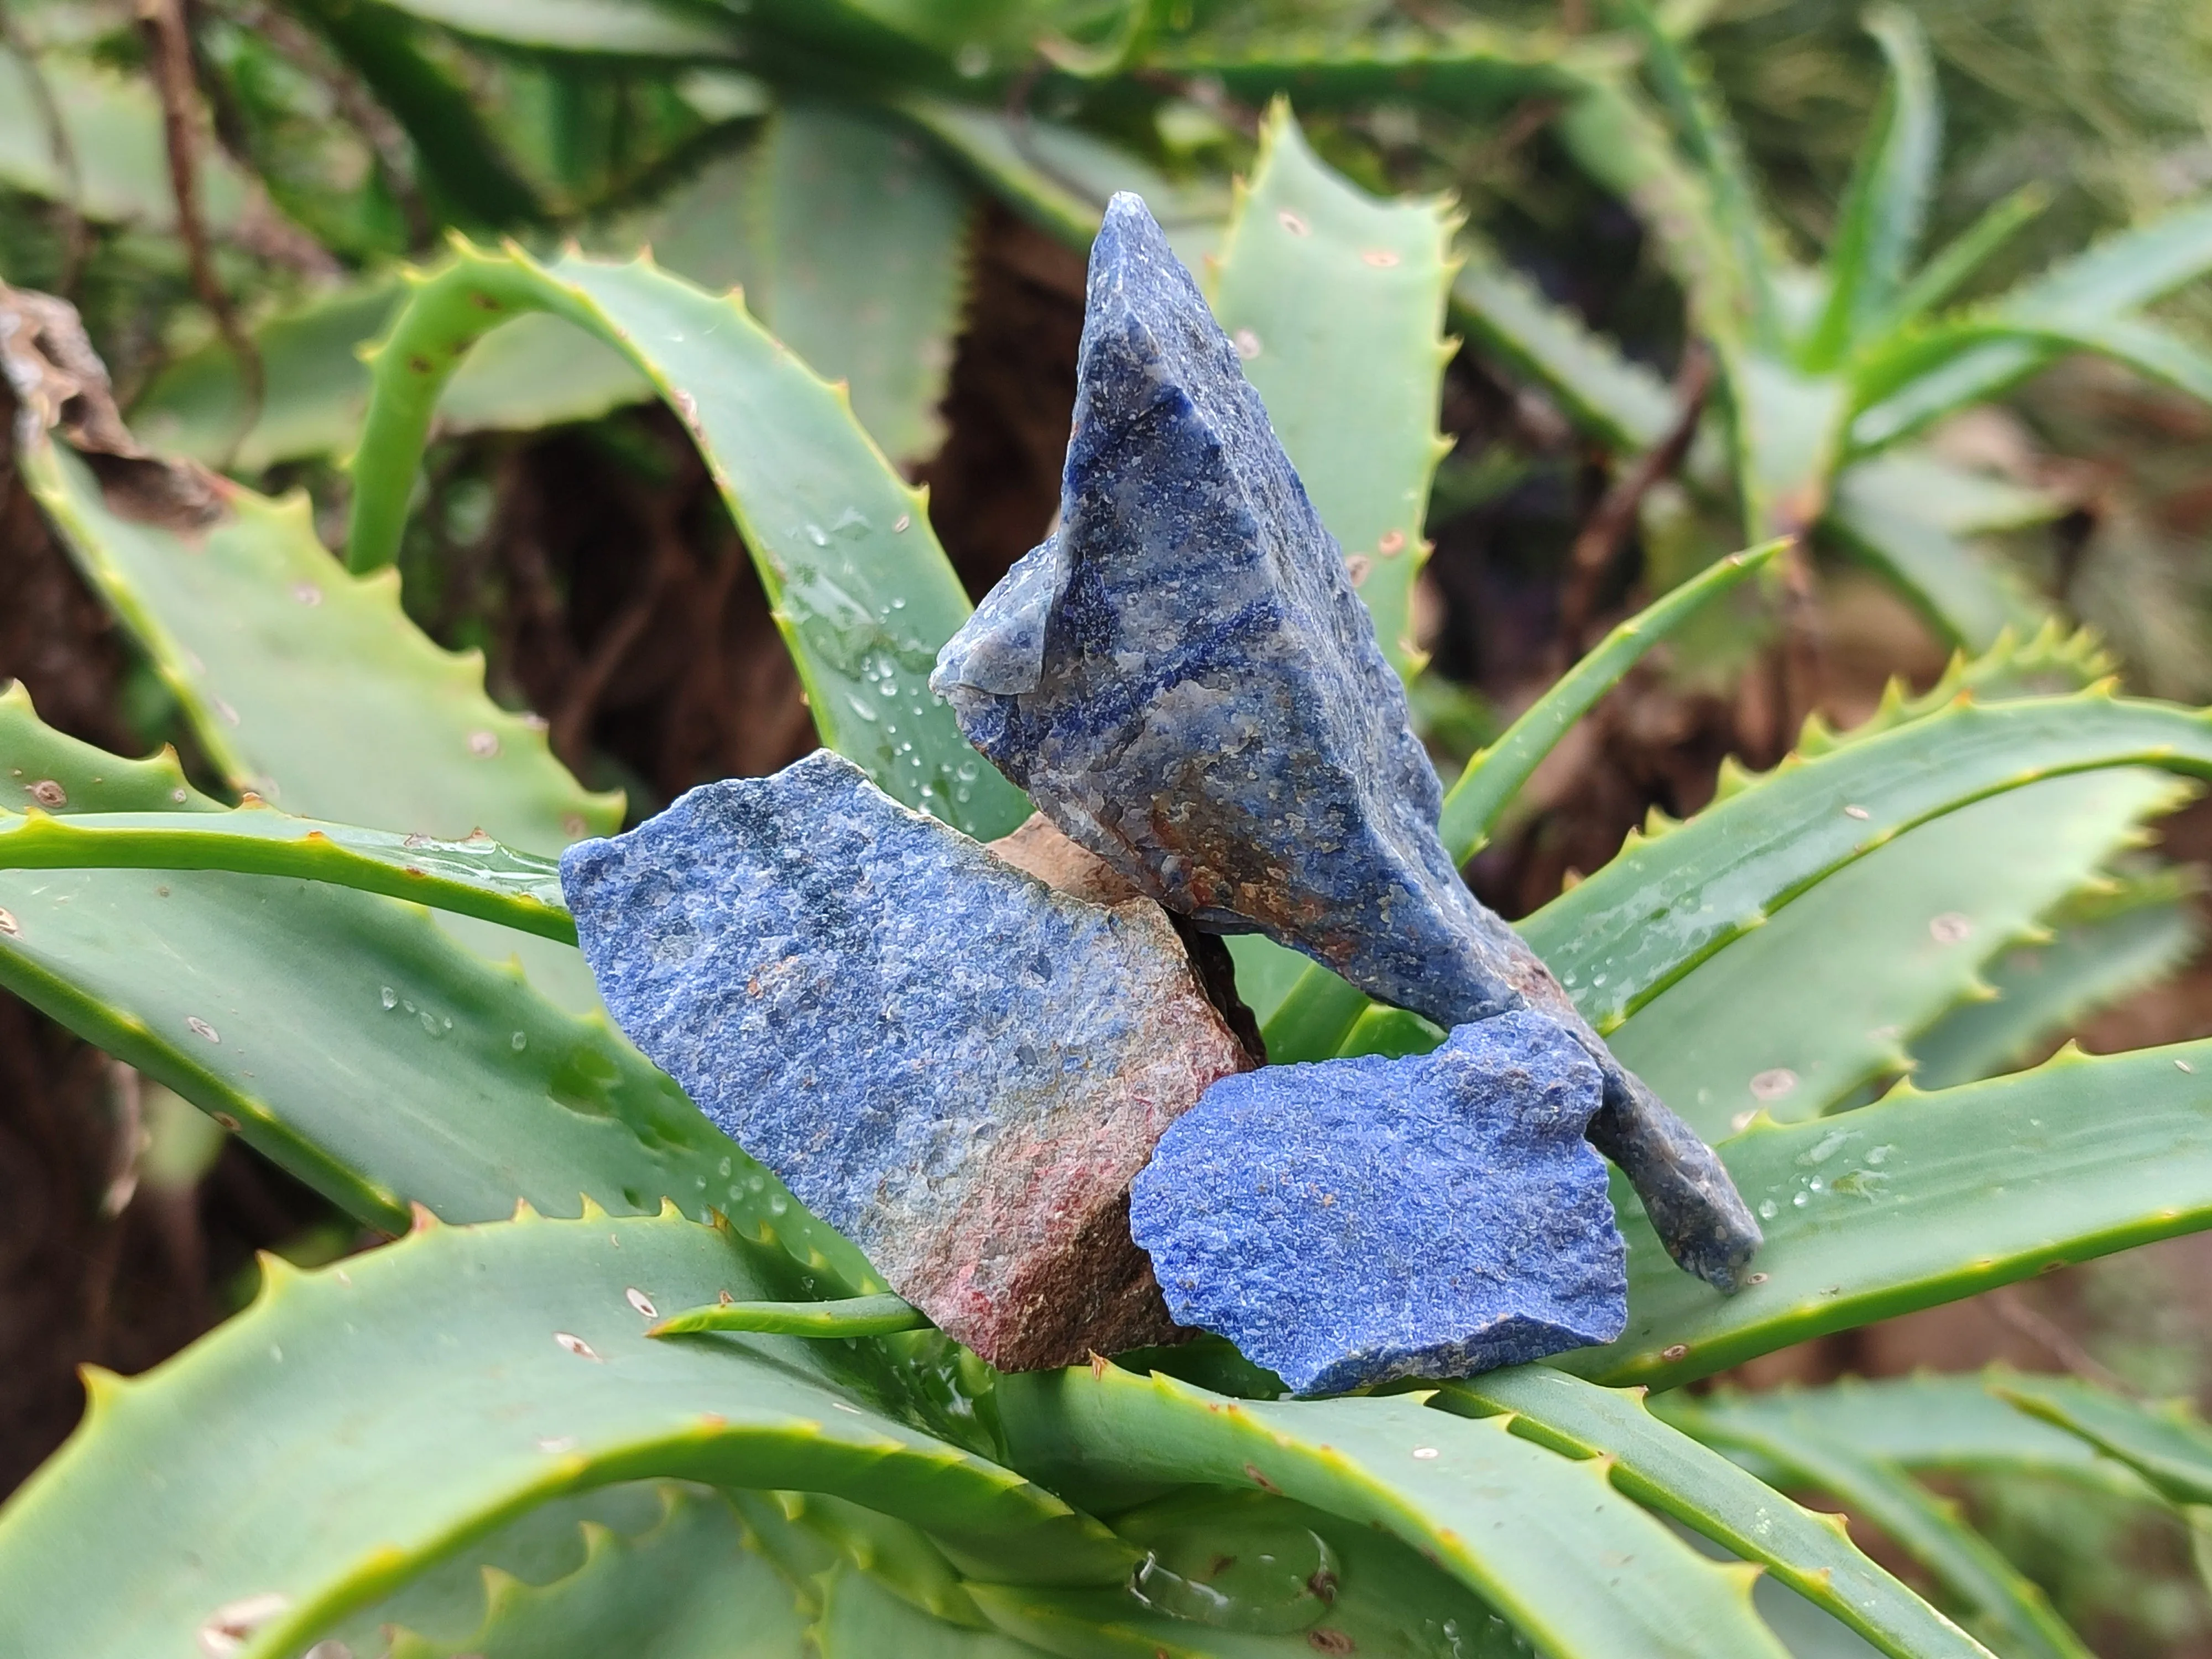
[0,0,2212,1655]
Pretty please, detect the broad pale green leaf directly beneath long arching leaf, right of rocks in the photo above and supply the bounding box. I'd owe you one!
[1608,768,2190,1139]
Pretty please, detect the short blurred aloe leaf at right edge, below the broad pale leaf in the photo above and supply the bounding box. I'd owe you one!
[1911,872,2203,1088]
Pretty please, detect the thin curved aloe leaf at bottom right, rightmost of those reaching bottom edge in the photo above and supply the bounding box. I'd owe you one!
[1672,1402,2095,1659]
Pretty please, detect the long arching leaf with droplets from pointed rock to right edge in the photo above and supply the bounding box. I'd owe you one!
[1522,692,2212,1031]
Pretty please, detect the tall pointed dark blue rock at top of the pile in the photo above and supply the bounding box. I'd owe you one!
[929,195,1759,1287]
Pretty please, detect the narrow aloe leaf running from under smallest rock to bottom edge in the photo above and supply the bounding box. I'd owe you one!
[1436,1365,1989,1659]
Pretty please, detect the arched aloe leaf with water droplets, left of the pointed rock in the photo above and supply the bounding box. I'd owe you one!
[349,243,1026,836]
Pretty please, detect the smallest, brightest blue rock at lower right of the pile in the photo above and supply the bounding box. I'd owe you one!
[1130,1013,1628,1394]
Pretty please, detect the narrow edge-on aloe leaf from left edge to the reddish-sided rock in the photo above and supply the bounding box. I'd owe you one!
[0,803,575,945]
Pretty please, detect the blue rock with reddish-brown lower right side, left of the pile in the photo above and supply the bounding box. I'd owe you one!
[562,752,1252,1369]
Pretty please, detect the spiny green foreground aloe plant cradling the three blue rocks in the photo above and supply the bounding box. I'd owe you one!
[0,88,2212,1659]
